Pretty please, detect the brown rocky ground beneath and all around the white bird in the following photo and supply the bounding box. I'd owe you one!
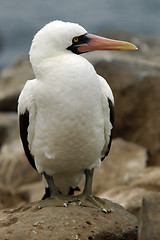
[0,32,160,240]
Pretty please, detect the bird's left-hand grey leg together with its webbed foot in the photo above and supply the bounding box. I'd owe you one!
[39,172,69,208]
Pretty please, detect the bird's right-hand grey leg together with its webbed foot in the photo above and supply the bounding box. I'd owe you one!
[77,169,111,212]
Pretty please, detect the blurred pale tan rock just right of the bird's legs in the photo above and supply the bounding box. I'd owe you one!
[93,138,147,195]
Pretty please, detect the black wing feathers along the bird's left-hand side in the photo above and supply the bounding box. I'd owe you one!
[19,110,37,170]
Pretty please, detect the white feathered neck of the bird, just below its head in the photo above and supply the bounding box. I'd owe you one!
[32,53,93,82]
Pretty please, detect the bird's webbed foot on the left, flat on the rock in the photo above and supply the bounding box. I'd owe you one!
[39,194,73,208]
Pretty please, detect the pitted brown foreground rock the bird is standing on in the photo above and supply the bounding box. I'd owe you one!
[0,202,137,240]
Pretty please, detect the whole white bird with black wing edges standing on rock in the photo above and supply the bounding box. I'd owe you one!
[18,21,136,212]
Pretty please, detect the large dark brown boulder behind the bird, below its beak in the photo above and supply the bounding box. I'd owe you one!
[96,61,160,165]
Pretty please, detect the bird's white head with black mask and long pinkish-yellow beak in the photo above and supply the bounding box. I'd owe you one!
[30,20,137,68]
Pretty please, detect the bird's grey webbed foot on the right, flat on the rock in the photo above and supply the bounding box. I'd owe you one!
[75,193,111,213]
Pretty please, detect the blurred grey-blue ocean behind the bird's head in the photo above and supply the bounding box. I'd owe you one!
[0,0,160,68]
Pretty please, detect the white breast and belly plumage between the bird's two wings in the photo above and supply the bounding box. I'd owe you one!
[30,55,104,171]
